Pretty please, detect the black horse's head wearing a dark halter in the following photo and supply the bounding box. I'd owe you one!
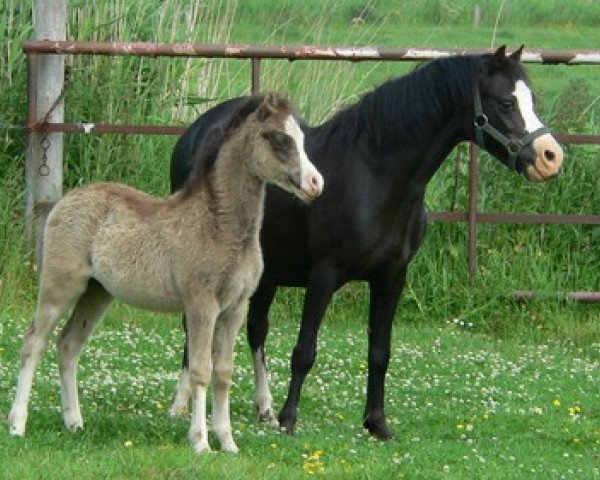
[473,46,563,182]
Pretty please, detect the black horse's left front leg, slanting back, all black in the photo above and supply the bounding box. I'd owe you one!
[279,263,338,434]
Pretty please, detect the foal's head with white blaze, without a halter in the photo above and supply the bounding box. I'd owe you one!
[252,93,323,201]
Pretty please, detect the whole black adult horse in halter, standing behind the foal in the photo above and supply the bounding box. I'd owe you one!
[171,47,563,439]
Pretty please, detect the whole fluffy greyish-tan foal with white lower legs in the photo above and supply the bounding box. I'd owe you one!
[9,94,323,452]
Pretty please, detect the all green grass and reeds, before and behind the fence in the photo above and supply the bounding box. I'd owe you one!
[0,0,600,479]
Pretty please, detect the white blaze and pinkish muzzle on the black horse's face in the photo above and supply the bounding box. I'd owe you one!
[513,80,564,182]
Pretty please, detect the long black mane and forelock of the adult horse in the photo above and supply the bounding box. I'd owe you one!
[320,54,524,150]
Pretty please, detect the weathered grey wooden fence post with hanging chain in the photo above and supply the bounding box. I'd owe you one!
[25,0,67,262]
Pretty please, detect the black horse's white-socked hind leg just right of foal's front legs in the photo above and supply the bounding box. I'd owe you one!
[247,281,277,423]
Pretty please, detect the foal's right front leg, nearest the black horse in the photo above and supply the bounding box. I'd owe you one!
[212,299,248,452]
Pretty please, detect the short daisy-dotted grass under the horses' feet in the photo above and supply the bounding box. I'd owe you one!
[0,302,600,479]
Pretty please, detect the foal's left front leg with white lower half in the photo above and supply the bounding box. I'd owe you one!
[185,295,219,453]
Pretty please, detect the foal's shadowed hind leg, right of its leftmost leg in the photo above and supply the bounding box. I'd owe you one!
[57,279,112,431]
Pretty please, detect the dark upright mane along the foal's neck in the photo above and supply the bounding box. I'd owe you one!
[181,94,265,198]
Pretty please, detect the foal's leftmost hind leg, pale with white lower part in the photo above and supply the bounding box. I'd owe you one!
[8,271,87,436]
